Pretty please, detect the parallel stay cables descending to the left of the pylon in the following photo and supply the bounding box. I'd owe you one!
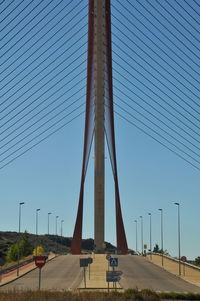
[0,0,87,169]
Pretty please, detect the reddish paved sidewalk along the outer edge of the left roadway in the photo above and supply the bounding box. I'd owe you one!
[0,254,56,286]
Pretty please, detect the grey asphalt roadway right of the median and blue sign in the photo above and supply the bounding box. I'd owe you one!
[118,255,200,293]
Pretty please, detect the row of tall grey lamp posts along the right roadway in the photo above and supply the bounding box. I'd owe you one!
[134,202,181,276]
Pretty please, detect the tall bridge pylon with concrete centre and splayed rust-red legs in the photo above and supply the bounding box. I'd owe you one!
[71,0,128,254]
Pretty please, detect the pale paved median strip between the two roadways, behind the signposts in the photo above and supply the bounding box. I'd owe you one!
[79,254,121,290]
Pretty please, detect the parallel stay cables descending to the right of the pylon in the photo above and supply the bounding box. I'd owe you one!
[112,0,200,170]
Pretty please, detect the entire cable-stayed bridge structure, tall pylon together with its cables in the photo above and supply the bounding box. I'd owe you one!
[0,0,200,290]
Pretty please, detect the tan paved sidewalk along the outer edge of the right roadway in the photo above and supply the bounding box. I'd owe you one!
[146,254,200,286]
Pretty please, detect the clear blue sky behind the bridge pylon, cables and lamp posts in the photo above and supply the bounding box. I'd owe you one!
[0,0,200,258]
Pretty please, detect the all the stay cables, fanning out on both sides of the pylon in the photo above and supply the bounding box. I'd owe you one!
[0,0,200,170]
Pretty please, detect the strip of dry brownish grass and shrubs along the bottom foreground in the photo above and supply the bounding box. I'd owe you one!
[0,289,200,301]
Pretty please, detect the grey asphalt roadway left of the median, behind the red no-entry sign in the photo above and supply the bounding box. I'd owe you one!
[0,255,83,291]
